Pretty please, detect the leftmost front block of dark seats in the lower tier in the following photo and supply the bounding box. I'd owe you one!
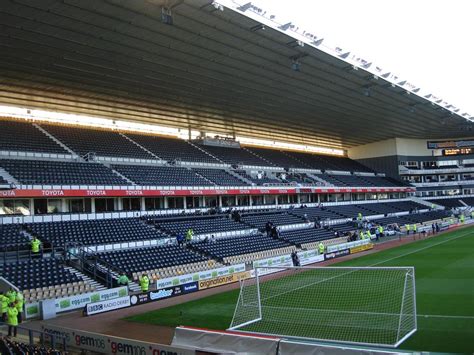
[0,258,83,290]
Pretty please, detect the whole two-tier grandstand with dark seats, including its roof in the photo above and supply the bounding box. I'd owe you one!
[0,0,474,354]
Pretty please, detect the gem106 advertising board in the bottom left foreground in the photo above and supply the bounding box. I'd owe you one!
[42,325,195,355]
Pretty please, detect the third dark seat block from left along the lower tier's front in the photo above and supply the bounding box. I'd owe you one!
[193,235,288,260]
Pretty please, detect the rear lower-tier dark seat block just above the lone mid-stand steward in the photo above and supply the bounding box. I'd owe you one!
[146,215,250,235]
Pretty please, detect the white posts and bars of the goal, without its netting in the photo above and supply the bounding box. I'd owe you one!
[227,265,418,348]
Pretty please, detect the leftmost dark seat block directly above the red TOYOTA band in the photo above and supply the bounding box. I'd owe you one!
[0,159,129,185]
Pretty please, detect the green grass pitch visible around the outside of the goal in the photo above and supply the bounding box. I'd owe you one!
[127,227,474,353]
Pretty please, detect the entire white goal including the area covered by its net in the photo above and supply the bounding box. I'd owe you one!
[229,266,417,347]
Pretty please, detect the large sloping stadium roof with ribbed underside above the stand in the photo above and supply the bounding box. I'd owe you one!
[0,0,472,149]
